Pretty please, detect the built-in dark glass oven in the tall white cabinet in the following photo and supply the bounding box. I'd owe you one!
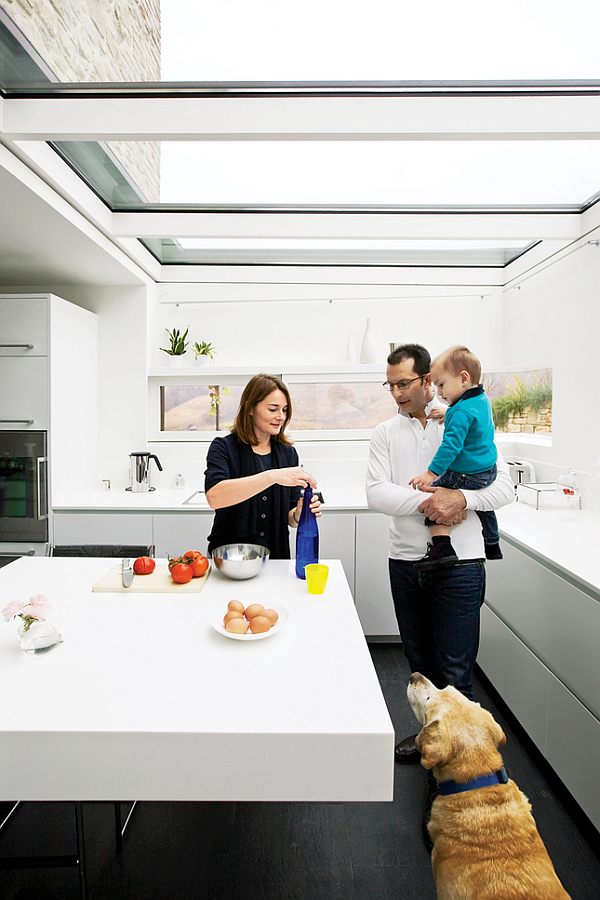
[0,431,48,543]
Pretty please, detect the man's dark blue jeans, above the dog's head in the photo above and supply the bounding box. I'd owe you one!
[389,559,485,700]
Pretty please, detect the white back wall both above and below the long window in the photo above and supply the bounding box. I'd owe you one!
[138,284,502,495]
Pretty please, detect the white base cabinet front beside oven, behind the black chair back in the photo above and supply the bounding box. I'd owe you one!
[53,513,153,546]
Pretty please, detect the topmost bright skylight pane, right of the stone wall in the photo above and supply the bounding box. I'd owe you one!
[161,0,600,81]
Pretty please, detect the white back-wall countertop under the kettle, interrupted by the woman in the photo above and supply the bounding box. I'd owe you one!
[52,486,367,512]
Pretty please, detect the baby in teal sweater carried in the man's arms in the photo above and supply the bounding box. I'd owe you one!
[409,347,502,571]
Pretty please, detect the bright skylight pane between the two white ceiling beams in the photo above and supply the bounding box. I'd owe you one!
[161,141,600,207]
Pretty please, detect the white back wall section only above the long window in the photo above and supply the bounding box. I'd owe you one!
[148,284,503,373]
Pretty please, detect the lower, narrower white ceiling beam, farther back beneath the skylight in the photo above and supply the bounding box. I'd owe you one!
[112,211,581,241]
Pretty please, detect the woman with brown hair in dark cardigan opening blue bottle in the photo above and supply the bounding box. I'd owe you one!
[204,374,321,559]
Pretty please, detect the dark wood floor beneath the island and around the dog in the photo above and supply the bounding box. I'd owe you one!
[0,644,600,900]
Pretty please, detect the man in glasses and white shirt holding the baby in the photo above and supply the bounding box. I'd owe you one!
[367,344,514,762]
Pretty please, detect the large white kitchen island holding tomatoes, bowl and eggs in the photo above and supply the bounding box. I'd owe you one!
[0,557,394,801]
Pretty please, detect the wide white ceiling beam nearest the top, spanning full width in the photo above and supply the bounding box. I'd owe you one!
[0,95,600,141]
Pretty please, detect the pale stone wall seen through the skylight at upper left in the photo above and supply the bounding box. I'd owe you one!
[0,0,160,202]
